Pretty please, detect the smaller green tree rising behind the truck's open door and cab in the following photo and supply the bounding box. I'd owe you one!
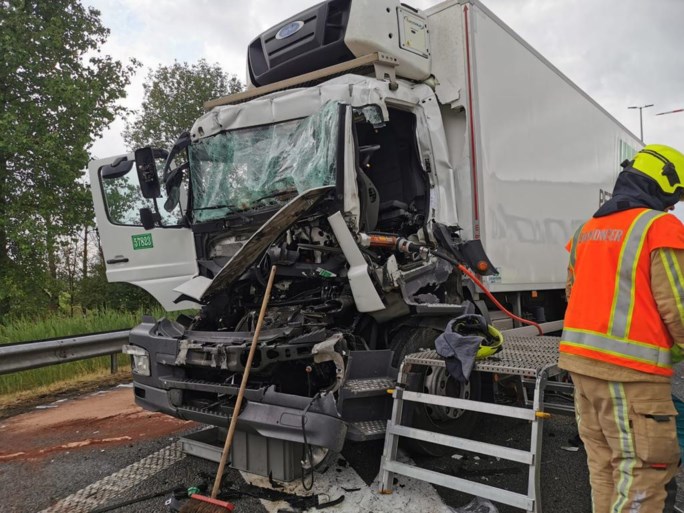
[123,59,243,149]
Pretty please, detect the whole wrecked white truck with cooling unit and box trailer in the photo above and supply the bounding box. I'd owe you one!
[90,0,641,478]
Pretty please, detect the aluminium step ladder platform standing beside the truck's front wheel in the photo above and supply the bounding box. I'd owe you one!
[380,336,572,513]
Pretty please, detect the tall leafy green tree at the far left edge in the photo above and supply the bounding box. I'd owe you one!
[0,0,137,321]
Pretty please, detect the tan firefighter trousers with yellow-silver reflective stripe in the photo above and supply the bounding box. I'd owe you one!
[571,372,679,513]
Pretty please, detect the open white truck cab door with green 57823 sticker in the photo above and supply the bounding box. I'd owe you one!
[88,153,198,311]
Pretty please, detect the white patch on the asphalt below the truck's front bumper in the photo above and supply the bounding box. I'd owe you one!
[240,451,451,513]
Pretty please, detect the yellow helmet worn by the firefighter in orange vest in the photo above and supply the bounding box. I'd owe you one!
[630,144,684,194]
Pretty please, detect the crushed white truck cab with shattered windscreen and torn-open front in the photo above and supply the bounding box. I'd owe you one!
[95,76,484,451]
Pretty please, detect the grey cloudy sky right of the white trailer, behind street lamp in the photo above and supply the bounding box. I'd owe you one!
[472,0,684,150]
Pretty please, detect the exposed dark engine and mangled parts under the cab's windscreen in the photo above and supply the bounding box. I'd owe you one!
[176,204,453,397]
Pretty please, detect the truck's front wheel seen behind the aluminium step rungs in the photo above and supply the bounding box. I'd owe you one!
[392,328,481,456]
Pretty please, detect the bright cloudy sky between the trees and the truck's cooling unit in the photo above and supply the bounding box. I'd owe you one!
[84,0,324,157]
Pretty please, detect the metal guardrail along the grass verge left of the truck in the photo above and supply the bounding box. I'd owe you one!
[0,330,130,375]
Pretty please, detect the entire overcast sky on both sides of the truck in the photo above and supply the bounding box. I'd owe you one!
[87,0,684,157]
